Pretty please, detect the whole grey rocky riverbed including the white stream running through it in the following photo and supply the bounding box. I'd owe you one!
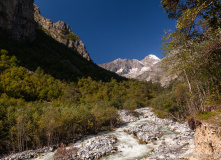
[2,107,194,160]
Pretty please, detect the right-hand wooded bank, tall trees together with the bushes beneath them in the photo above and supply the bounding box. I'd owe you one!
[150,0,221,119]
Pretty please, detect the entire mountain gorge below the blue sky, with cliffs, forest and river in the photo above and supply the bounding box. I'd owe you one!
[0,0,221,160]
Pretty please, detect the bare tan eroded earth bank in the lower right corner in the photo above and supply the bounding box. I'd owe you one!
[191,123,221,160]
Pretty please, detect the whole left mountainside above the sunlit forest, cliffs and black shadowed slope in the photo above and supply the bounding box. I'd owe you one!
[0,0,124,81]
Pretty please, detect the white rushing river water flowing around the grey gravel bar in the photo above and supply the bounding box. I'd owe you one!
[32,108,193,160]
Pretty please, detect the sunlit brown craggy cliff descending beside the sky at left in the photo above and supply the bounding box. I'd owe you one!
[34,4,91,60]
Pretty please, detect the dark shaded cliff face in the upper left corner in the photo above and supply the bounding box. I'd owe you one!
[0,0,35,41]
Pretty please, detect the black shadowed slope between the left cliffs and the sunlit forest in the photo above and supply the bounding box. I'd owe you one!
[0,30,124,81]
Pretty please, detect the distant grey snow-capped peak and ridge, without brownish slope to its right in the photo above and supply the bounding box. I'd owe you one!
[99,55,161,78]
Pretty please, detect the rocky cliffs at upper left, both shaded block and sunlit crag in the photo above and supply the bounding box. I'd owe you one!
[0,0,91,61]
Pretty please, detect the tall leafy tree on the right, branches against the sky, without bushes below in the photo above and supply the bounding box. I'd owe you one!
[161,0,221,113]
